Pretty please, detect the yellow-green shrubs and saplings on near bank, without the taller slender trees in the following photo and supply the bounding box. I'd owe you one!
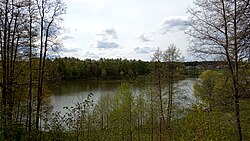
[4,71,250,141]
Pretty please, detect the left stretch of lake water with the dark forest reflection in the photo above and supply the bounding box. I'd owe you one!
[50,80,121,111]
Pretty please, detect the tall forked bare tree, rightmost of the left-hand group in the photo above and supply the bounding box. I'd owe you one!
[36,0,65,129]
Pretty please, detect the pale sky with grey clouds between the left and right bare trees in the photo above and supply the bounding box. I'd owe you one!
[59,0,193,60]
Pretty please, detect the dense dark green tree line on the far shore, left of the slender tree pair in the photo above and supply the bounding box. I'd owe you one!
[53,57,149,79]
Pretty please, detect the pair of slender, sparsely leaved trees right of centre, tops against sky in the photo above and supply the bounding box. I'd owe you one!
[149,44,184,140]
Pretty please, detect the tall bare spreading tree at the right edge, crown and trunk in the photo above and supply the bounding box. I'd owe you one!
[187,0,250,141]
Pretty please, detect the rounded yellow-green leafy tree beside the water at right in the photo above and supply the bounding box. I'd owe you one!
[194,70,236,113]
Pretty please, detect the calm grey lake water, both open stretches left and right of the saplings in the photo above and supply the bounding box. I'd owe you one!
[51,79,195,112]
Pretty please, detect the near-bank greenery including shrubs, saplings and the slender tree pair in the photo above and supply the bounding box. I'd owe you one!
[1,46,250,141]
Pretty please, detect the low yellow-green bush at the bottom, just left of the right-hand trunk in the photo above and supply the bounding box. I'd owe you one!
[174,105,236,141]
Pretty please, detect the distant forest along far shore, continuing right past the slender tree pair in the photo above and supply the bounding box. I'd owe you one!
[53,57,225,80]
